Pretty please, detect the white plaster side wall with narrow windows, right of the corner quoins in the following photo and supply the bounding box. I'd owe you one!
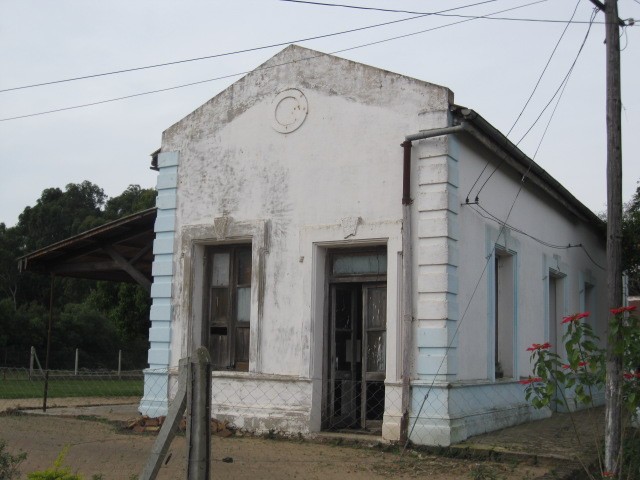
[450,136,607,380]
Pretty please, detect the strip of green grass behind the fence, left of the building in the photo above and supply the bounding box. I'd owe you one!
[0,372,144,399]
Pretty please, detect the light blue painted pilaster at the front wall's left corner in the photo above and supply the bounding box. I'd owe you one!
[139,152,179,417]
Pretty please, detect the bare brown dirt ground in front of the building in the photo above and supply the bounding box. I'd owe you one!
[0,413,557,480]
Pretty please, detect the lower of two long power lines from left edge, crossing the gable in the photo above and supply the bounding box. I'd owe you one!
[0,0,547,122]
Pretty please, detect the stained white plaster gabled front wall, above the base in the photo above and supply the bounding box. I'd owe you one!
[162,47,451,392]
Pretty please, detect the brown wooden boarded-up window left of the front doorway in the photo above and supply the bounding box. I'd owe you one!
[204,245,251,371]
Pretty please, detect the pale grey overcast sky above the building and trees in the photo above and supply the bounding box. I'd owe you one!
[0,0,640,226]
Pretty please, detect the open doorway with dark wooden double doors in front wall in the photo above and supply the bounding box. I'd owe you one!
[324,251,387,433]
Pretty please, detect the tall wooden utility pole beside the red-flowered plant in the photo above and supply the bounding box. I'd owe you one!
[604,0,622,477]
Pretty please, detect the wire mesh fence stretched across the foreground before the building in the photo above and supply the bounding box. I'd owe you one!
[0,368,608,479]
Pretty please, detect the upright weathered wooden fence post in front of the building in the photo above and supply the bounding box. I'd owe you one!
[187,347,211,480]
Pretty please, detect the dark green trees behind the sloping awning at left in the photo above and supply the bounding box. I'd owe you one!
[0,181,156,369]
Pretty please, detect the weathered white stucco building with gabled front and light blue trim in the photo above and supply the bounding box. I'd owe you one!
[140,46,606,445]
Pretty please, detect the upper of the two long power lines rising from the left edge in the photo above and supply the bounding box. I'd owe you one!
[0,0,497,93]
